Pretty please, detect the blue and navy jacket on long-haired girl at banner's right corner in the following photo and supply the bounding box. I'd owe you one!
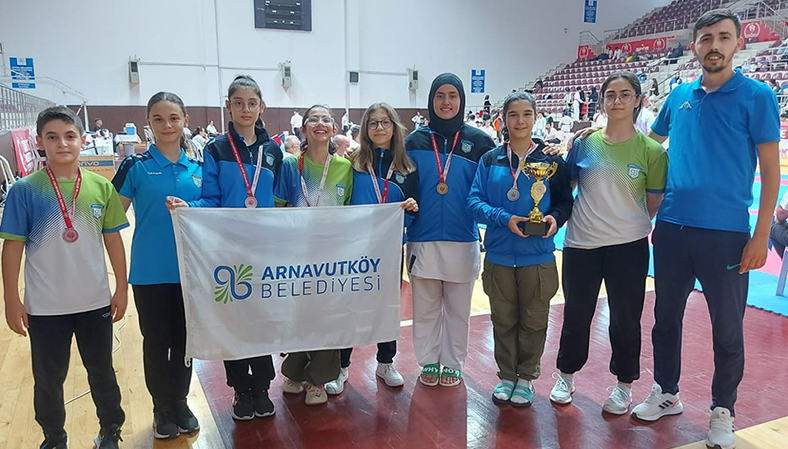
[350,148,419,240]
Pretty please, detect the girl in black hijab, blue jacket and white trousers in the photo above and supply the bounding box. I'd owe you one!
[405,73,495,387]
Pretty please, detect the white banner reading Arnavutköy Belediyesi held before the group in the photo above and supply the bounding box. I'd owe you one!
[172,203,403,360]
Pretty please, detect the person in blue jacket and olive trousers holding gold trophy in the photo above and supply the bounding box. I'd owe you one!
[468,92,573,407]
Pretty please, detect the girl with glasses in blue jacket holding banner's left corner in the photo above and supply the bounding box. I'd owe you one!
[170,75,282,420]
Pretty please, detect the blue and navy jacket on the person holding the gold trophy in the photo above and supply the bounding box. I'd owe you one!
[468,139,574,267]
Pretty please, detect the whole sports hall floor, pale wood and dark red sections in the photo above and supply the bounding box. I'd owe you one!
[0,196,788,449]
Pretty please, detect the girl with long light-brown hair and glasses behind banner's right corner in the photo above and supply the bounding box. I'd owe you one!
[326,103,419,394]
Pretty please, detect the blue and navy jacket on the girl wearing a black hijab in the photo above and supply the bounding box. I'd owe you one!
[405,124,495,242]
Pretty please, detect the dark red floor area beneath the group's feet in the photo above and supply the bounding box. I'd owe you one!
[196,293,788,449]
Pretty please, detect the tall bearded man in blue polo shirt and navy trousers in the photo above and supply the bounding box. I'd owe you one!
[632,9,780,449]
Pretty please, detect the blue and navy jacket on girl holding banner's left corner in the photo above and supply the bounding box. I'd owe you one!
[189,122,282,207]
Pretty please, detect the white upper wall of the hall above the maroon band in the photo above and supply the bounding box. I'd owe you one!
[0,0,669,108]
